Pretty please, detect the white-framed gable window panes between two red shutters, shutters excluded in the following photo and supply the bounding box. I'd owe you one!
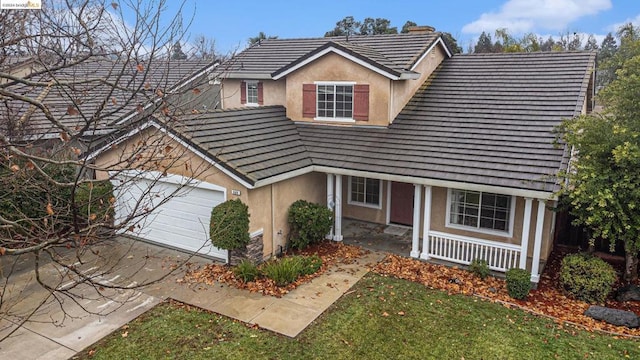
[317,84,353,119]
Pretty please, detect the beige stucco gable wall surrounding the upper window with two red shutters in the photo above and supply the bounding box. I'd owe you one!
[286,53,391,126]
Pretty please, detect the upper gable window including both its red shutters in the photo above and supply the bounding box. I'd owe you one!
[302,81,369,122]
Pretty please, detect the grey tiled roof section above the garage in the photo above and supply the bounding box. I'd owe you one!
[158,106,311,185]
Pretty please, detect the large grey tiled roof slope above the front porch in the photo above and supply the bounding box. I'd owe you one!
[297,52,595,192]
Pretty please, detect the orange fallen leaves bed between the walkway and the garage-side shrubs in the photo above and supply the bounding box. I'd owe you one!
[178,242,368,297]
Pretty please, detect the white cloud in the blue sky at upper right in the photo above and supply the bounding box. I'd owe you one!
[462,0,611,34]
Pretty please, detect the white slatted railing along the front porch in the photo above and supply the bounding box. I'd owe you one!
[428,231,521,272]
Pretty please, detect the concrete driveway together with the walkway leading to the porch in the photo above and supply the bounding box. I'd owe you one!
[0,238,384,359]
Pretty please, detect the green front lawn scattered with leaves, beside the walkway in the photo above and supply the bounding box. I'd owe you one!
[79,274,640,359]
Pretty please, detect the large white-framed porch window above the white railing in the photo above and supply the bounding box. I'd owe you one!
[447,189,513,233]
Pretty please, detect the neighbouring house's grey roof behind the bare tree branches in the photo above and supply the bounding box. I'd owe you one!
[0,58,218,138]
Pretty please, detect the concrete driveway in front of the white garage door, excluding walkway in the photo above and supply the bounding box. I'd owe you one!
[0,237,211,359]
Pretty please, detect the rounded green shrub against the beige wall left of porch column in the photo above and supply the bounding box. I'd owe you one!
[288,200,333,249]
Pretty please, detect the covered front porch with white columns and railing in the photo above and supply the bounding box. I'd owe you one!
[327,174,553,283]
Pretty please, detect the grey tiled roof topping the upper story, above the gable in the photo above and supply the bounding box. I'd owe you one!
[221,32,448,78]
